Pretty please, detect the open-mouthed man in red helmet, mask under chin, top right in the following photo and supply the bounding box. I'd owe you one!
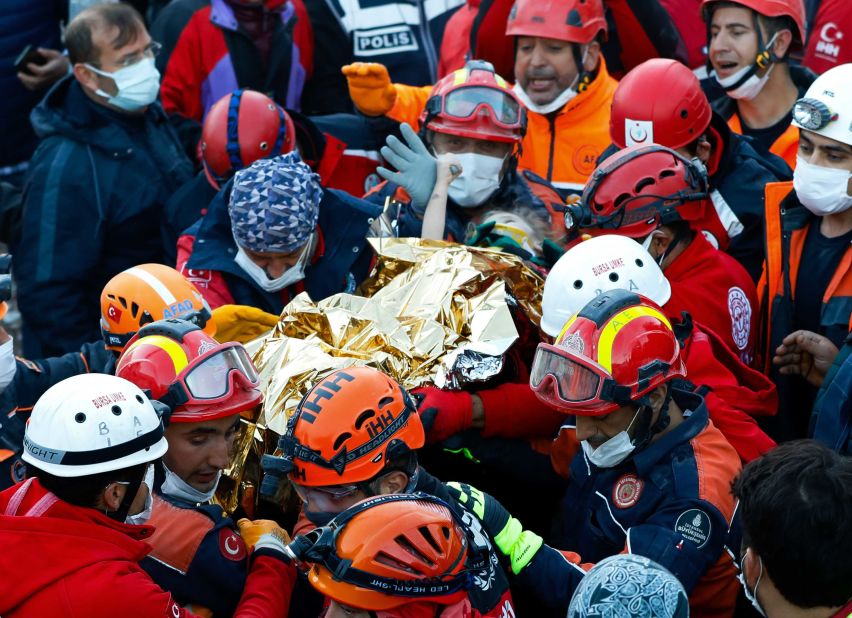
[701,0,816,168]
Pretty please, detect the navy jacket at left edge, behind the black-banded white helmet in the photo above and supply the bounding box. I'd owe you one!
[0,341,116,491]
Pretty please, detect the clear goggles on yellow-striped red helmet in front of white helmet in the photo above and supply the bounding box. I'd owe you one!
[530,338,631,414]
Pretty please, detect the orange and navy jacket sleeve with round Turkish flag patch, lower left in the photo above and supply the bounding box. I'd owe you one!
[139,482,248,618]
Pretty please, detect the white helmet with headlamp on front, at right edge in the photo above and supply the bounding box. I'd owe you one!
[793,64,852,146]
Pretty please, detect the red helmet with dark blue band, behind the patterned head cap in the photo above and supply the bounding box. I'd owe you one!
[201,90,296,189]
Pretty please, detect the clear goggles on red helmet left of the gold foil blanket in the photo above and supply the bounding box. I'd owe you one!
[160,342,260,409]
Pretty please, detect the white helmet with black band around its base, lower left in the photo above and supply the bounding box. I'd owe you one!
[22,373,168,477]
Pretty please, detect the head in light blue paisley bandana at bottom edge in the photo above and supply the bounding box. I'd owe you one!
[568,554,689,618]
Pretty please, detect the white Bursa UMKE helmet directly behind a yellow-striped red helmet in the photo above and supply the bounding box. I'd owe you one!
[541,234,672,337]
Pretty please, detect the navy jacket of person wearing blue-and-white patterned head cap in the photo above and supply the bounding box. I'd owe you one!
[178,180,381,313]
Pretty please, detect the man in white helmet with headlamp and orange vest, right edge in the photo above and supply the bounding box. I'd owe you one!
[758,64,852,441]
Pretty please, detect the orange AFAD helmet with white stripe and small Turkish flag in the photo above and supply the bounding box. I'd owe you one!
[101,264,216,352]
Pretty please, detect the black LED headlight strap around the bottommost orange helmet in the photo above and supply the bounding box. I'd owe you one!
[288,492,491,599]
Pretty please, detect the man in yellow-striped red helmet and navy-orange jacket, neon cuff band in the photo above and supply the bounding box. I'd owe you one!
[455,290,740,616]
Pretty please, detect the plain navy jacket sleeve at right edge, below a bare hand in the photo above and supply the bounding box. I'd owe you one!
[810,335,852,455]
